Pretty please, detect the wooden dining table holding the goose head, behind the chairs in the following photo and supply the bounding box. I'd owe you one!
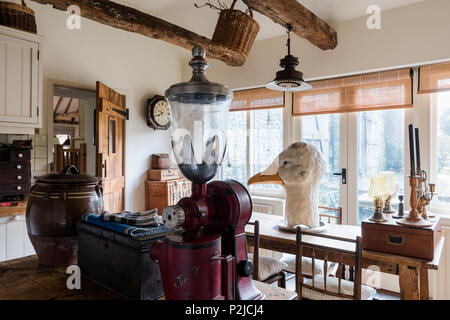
[246,213,445,300]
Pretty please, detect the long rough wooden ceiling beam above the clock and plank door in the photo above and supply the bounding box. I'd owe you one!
[29,0,246,66]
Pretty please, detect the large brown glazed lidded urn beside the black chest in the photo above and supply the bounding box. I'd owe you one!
[26,166,103,266]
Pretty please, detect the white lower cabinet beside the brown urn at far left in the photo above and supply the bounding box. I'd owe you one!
[0,214,35,261]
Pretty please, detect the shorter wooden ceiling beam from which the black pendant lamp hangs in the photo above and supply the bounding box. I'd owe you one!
[244,0,338,50]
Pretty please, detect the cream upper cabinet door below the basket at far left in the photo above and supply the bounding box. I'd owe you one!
[0,34,39,124]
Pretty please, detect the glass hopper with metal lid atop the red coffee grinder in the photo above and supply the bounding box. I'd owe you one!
[166,47,233,183]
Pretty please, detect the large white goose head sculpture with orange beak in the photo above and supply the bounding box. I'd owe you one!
[248,142,327,229]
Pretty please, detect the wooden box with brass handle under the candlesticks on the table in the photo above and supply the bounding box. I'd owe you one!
[361,216,441,260]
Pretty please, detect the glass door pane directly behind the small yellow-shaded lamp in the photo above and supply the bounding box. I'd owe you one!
[356,109,405,225]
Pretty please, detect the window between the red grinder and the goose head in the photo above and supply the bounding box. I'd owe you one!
[220,108,283,194]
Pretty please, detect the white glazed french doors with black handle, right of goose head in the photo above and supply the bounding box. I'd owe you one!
[300,109,412,225]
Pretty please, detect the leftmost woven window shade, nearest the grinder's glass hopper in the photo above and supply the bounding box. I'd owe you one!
[230,88,284,111]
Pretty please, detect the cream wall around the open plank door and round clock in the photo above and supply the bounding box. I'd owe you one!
[28,1,188,210]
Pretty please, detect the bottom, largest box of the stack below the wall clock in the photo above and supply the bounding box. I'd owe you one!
[145,179,192,215]
